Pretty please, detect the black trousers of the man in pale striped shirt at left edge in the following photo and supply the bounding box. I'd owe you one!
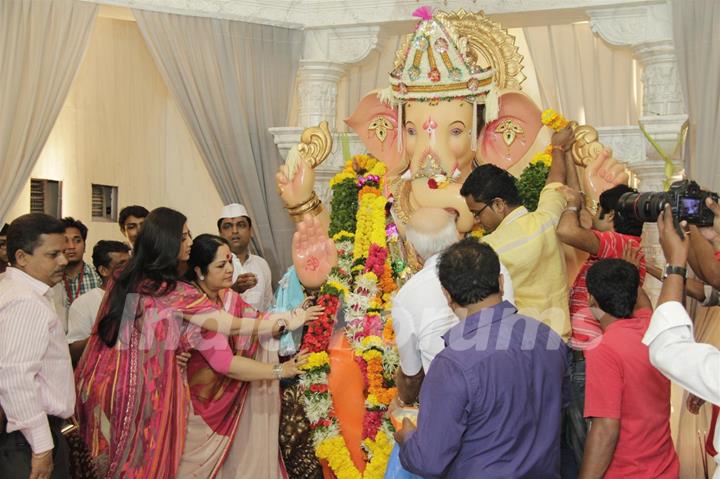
[0,416,70,479]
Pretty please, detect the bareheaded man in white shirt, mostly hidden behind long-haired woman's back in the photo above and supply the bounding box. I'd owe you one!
[67,240,130,365]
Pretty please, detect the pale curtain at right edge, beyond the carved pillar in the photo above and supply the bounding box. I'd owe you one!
[672,0,720,191]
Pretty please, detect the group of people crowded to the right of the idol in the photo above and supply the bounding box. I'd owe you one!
[386,125,720,479]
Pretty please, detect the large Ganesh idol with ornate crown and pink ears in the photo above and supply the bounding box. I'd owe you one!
[277,8,628,477]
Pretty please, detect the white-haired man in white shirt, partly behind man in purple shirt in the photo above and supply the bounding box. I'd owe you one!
[392,208,515,406]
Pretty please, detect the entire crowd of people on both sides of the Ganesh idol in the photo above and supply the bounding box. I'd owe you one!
[0,128,720,479]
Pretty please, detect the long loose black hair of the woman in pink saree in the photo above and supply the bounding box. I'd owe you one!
[98,208,187,347]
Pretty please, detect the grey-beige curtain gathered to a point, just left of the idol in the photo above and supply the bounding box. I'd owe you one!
[133,10,302,279]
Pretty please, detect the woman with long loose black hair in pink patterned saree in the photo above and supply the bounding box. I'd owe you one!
[75,208,318,479]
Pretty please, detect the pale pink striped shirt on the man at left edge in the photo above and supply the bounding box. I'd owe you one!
[0,267,75,454]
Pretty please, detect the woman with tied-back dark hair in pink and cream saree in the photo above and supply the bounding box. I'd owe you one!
[178,235,306,479]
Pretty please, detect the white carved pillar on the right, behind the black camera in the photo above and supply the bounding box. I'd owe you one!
[588,1,687,296]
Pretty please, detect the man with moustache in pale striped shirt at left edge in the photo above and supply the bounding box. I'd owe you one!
[0,214,75,478]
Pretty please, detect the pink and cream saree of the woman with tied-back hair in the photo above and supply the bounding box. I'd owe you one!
[178,291,287,479]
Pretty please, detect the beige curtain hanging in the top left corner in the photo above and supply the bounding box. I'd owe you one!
[0,0,97,224]
